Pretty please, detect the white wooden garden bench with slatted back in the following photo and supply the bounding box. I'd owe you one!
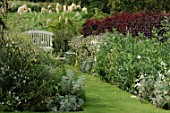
[24,30,54,51]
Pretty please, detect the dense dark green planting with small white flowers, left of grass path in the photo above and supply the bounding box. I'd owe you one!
[0,31,85,111]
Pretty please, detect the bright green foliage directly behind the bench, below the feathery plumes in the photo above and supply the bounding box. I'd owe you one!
[8,13,56,32]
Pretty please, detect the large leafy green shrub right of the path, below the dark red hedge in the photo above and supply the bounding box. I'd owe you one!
[97,30,169,90]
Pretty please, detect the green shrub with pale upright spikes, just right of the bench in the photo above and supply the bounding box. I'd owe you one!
[49,12,85,53]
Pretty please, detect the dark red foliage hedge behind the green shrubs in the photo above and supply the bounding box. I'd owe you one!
[83,12,167,37]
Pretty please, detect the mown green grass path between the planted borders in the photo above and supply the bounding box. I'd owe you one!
[65,65,170,113]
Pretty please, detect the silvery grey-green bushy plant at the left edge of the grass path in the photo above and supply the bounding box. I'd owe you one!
[42,70,85,112]
